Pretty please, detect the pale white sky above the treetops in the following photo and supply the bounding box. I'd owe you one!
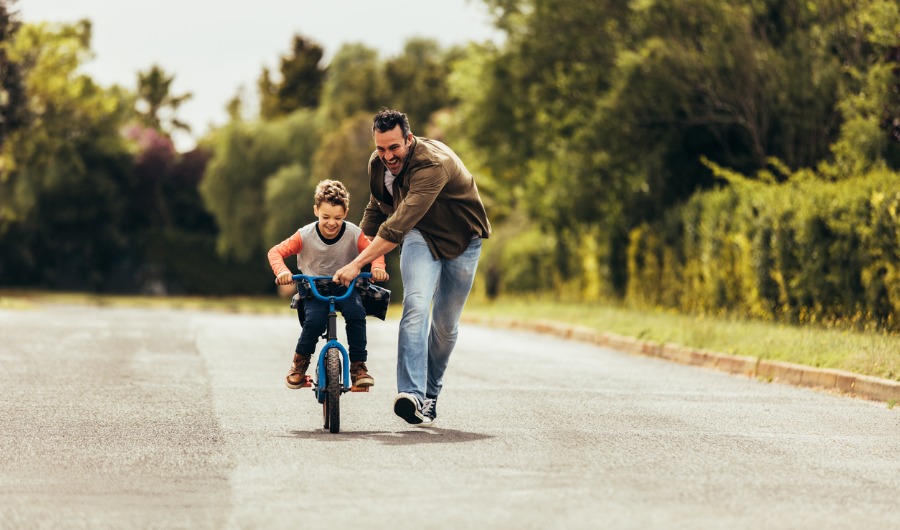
[12,0,503,151]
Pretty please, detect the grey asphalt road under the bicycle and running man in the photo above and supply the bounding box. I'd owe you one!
[0,306,900,529]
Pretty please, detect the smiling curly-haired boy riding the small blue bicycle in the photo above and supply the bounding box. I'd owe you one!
[268,180,389,389]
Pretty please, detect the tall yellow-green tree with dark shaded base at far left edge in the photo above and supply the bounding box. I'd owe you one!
[0,21,131,289]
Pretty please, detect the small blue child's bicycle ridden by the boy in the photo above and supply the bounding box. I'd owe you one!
[292,272,372,433]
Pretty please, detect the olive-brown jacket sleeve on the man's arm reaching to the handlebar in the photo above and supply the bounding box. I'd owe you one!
[378,164,450,244]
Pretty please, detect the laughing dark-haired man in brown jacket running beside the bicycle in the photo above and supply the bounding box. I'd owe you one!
[334,109,491,426]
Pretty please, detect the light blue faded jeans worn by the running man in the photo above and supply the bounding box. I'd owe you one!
[397,229,481,399]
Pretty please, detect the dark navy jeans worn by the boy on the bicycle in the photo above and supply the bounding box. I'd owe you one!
[296,290,368,362]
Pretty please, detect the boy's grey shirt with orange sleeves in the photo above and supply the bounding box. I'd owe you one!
[268,221,385,276]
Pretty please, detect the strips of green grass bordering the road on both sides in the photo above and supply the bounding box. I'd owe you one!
[0,291,900,381]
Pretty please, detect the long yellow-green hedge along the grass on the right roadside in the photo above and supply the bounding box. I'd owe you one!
[626,167,900,329]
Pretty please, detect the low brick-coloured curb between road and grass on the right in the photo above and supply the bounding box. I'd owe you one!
[463,316,900,403]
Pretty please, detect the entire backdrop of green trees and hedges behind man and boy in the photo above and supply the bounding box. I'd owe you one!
[8,0,900,310]
